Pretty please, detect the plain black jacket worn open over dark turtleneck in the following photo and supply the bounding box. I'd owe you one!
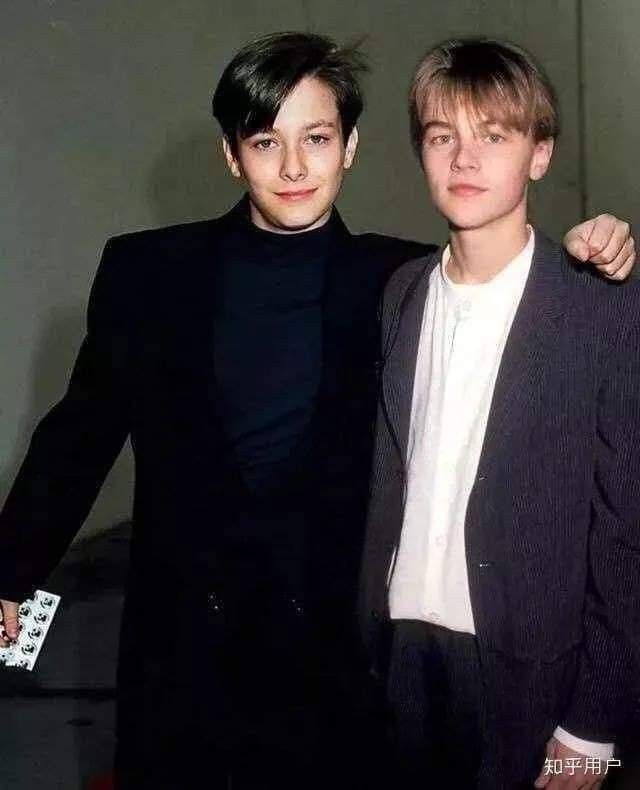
[0,201,426,736]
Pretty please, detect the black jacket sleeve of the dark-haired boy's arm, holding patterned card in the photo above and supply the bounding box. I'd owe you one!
[0,240,129,601]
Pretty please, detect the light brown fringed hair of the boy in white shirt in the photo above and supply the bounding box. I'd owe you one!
[409,38,560,156]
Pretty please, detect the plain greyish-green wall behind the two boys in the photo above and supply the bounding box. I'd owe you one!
[0,0,640,534]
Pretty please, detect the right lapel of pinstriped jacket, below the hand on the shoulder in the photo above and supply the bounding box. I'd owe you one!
[478,232,567,475]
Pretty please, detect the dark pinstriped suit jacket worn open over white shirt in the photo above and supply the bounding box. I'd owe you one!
[359,233,640,741]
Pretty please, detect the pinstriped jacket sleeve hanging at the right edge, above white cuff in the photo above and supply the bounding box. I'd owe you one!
[561,310,640,742]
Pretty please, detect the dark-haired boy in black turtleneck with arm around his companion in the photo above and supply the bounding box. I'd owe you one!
[0,33,633,790]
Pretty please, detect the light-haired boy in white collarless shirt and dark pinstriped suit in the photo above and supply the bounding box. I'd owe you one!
[361,39,640,790]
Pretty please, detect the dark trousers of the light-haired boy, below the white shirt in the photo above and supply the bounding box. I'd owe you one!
[388,620,556,790]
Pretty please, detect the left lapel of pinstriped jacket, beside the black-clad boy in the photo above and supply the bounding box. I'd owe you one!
[382,251,442,465]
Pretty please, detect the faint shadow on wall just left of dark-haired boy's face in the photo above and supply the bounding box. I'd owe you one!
[147,121,242,226]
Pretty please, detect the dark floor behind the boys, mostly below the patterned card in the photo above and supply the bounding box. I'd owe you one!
[0,525,640,790]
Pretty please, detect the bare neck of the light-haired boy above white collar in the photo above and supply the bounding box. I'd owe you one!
[447,213,529,285]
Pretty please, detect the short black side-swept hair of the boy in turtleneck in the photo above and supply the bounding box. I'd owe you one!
[212,32,367,151]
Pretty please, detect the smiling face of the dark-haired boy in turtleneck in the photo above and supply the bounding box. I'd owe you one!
[224,78,358,233]
